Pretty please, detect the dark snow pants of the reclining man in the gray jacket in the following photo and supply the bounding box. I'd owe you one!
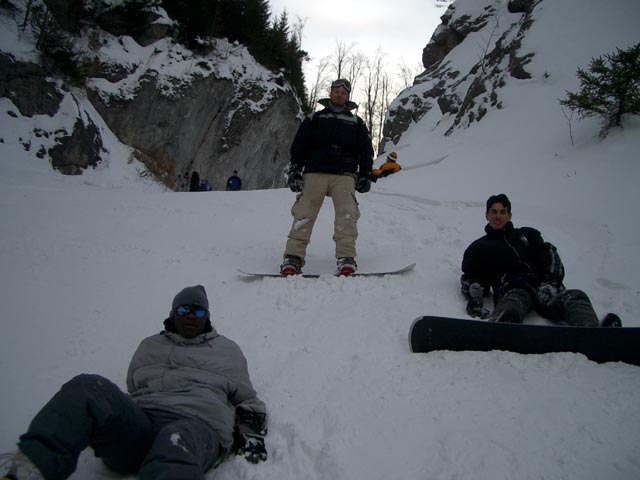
[18,374,220,480]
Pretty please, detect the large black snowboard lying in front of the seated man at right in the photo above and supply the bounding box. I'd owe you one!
[409,316,640,366]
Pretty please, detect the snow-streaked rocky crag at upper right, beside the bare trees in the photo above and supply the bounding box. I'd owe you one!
[380,0,542,151]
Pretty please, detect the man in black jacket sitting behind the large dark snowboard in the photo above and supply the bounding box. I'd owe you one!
[461,193,621,327]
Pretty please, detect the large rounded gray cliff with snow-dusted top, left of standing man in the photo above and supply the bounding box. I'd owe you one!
[83,32,300,190]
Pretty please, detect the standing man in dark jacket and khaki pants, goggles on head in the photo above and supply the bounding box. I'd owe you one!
[280,79,373,276]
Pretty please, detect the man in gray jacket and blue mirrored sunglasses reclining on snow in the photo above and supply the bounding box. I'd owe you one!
[3,285,267,480]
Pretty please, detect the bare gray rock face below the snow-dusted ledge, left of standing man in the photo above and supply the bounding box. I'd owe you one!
[89,72,299,190]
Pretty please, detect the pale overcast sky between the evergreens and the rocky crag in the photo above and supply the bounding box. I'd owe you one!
[269,0,445,88]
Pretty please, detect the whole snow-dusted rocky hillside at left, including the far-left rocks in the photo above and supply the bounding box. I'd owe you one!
[0,6,301,190]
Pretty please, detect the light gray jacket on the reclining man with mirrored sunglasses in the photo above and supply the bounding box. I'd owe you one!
[127,329,266,449]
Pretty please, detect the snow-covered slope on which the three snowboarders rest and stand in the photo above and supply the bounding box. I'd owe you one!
[0,0,640,480]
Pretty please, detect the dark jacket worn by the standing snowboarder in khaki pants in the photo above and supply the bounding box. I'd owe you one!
[291,99,373,177]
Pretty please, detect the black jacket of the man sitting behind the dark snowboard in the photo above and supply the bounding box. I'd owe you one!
[461,222,564,301]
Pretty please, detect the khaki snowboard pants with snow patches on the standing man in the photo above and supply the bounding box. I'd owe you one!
[285,173,360,259]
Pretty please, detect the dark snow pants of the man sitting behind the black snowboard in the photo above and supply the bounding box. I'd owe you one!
[491,288,599,327]
